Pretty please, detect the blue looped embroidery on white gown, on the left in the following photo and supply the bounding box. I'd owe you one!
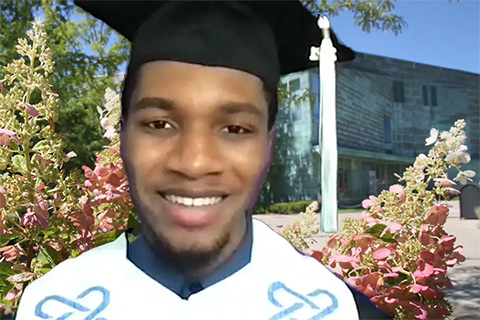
[35,286,110,320]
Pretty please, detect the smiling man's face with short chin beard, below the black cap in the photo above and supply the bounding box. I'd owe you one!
[121,61,271,262]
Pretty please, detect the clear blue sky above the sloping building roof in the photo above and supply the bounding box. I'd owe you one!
[330,0,480,74]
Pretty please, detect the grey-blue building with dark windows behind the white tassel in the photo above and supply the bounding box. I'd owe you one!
[277,53,480,206]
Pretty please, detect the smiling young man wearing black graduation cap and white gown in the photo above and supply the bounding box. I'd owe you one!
[17,1,390,320]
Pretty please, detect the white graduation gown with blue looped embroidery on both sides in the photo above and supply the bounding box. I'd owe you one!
[16,220,384,320]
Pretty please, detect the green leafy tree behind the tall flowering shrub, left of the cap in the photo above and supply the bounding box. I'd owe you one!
[0,0,129,169]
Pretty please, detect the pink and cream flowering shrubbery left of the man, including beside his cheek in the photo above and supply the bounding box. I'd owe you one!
[0,22,132,318]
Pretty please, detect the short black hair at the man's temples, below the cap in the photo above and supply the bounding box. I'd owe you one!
[121,68,278,131]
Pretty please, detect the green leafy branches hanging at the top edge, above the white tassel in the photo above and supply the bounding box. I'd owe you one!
[301,0,407,35]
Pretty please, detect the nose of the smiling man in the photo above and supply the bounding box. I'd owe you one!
[167,130,223,180]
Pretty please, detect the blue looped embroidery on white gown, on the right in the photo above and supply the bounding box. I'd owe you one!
[268,282,338,320]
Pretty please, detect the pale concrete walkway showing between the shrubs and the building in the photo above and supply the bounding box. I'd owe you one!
[254,201,480,320]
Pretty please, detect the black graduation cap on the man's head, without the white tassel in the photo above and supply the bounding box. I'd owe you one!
[74,0,354,126]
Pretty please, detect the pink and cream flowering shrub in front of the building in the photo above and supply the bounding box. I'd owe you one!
[304,120,475,319]
